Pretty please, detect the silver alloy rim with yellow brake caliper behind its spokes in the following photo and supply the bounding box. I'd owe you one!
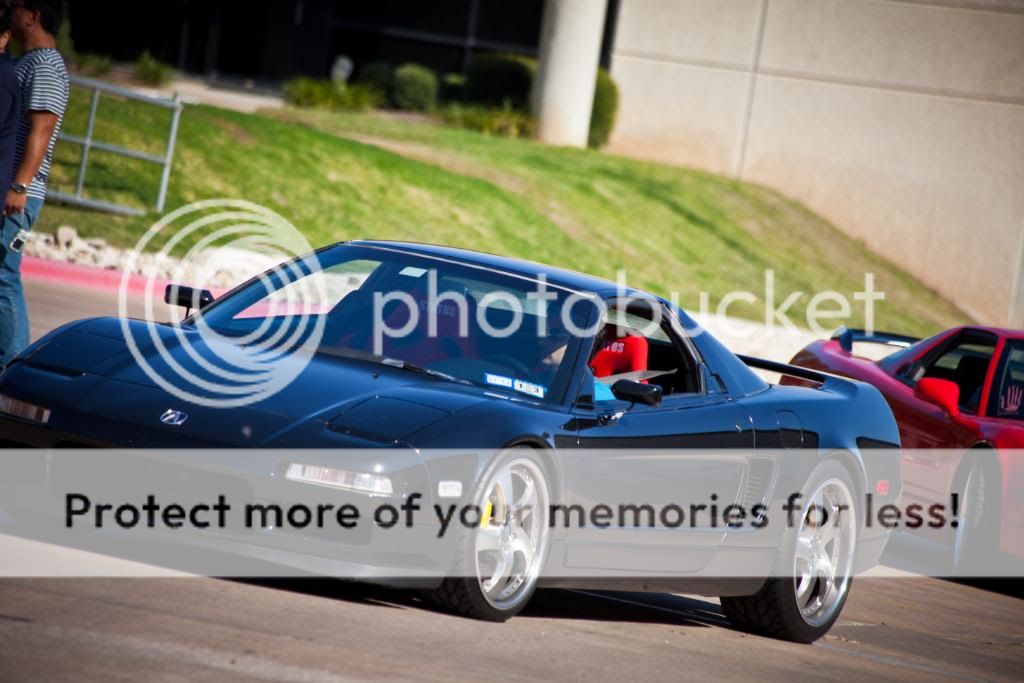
[474,458,548,609]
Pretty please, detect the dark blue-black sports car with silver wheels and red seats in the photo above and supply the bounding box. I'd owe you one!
[0,242,899,642]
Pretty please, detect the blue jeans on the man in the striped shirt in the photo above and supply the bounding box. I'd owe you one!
[0,197,43,371]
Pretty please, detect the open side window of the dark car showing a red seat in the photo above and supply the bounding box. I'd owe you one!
[580,302,700,405]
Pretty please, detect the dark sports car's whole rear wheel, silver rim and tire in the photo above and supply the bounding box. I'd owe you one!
[722,461,858,643]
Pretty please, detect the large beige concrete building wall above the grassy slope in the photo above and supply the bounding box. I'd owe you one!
[611,0,1024,327]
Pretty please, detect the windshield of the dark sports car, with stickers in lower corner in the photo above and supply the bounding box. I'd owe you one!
[189,246,598,400]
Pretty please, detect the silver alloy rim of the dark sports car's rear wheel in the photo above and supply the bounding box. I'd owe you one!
[793,478,857,626]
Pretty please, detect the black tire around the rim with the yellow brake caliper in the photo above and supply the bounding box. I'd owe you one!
[425,447,551,622]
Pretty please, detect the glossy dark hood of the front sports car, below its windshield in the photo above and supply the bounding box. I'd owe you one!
[18,318,486,446]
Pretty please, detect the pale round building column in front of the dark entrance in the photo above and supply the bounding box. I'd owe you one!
[532,0,607,147]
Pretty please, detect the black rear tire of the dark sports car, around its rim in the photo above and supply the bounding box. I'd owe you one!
[721,461,859,643]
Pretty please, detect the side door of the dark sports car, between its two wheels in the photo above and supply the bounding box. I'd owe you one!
[554,303,754,573]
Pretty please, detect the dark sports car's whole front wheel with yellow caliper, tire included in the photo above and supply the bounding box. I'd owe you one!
[430,449,551,622]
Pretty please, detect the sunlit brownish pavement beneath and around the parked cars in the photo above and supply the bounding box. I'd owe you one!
[0,283,1024,682]
